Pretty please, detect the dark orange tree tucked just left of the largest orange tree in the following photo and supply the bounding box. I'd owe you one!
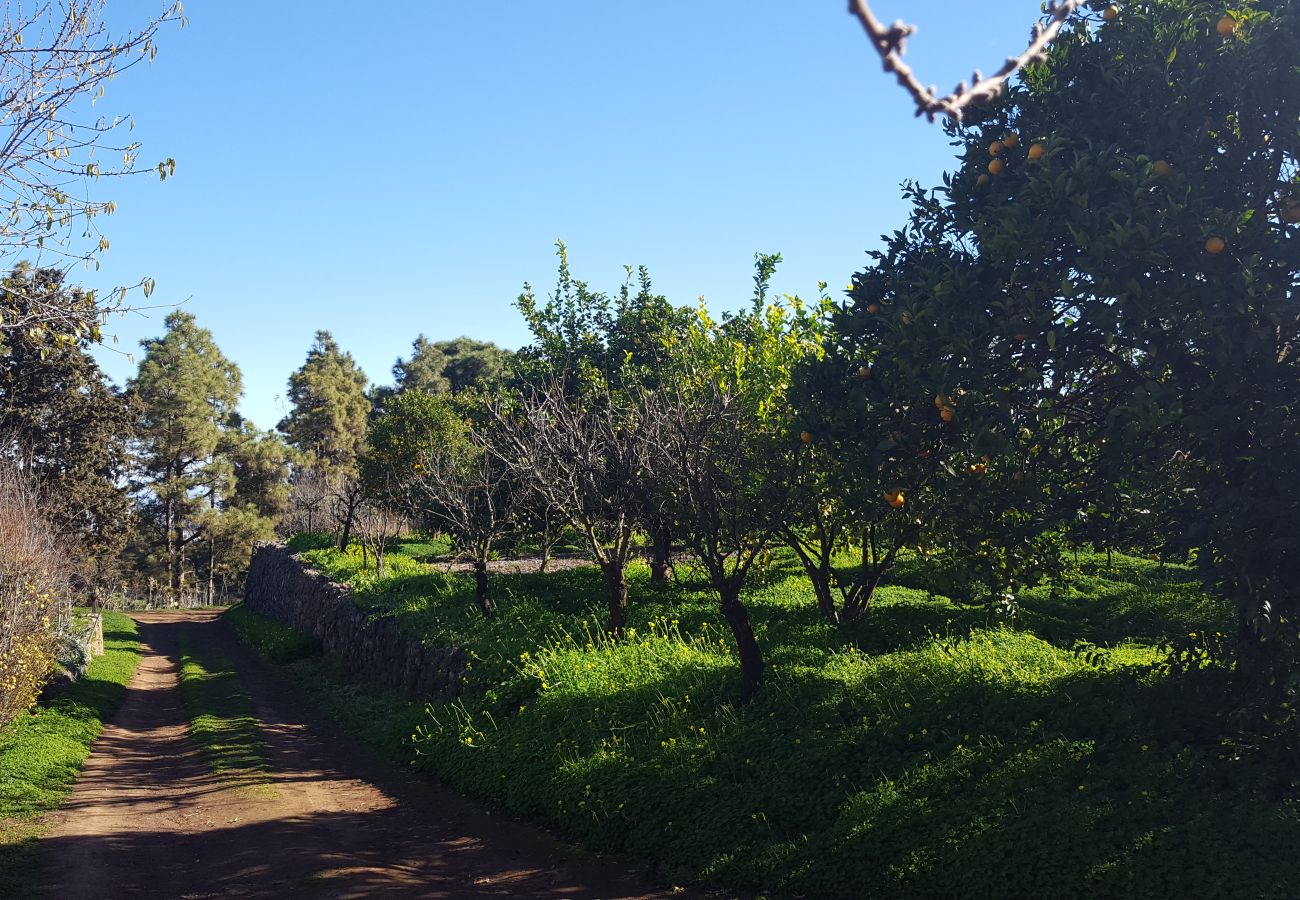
[793,201,1087,619]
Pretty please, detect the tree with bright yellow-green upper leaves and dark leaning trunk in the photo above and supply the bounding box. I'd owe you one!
[650,255,815,700]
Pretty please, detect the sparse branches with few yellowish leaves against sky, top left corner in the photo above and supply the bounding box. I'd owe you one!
[0,0,185,338]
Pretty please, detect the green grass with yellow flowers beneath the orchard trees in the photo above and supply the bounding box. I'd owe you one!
[239,541,1300,899]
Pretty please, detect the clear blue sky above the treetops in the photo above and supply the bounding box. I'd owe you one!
[74,0,1039,428]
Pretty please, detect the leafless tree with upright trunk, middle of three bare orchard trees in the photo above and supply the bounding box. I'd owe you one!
[495,378,658,633]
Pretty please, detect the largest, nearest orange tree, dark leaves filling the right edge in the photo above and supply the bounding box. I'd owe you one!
[819,0,1300,721]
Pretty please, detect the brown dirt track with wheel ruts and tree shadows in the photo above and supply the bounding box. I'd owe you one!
[43,610,685,899]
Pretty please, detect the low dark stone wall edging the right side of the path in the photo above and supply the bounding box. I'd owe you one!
[244,544,465,698]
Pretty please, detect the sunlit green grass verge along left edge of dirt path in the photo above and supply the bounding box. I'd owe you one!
[0,611,140,896]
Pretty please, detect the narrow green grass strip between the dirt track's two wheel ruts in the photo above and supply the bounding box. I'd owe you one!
[181,641,270,783]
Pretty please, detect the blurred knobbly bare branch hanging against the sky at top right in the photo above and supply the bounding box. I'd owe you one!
[849,0,1083,121]
